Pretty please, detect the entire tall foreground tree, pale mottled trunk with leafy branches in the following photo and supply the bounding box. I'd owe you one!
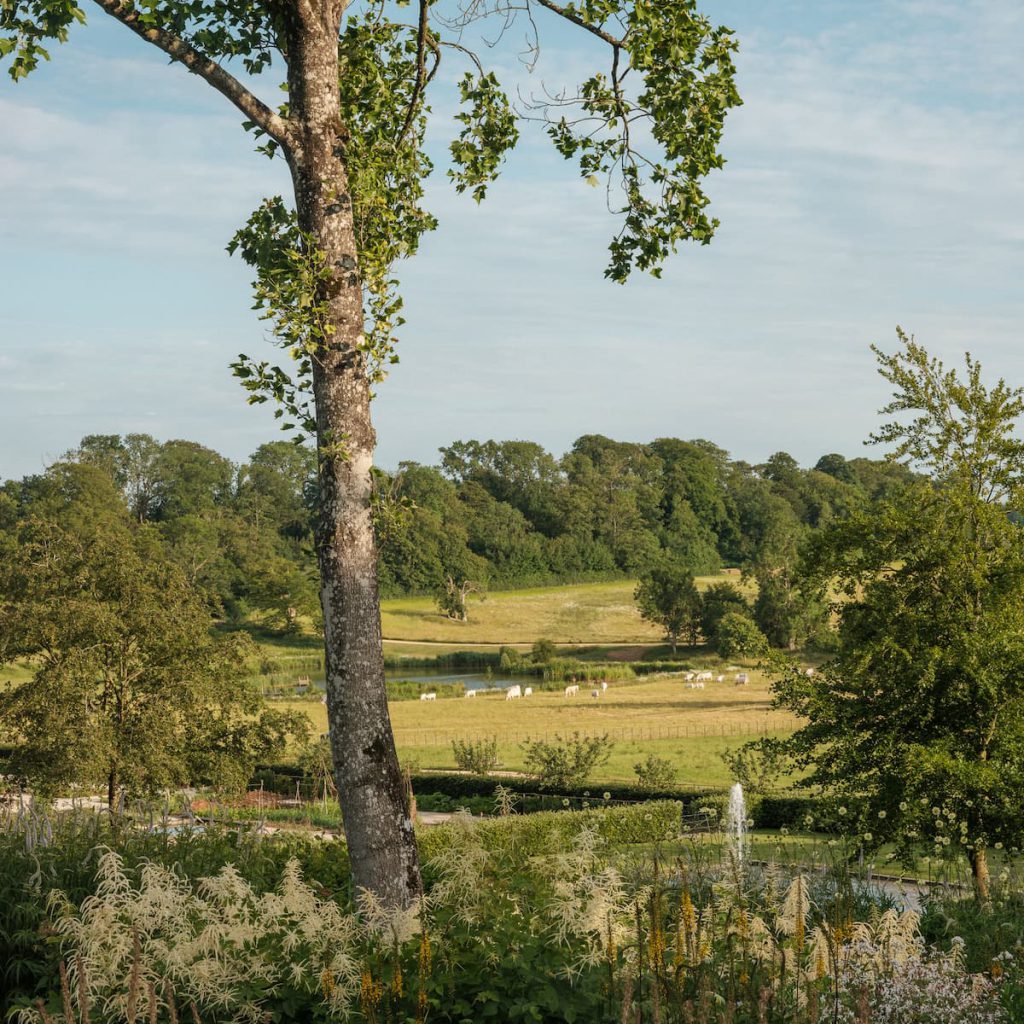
[0,0,739,904]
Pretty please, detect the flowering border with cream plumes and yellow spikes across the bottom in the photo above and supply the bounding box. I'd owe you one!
[8,812,1024,1024]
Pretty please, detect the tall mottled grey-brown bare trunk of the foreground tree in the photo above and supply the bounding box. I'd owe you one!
[288,3,422,906]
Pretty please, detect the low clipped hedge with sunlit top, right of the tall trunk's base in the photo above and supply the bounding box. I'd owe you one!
[418,800,682,860]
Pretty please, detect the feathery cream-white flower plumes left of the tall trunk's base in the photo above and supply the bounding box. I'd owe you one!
[29,850,366,1024]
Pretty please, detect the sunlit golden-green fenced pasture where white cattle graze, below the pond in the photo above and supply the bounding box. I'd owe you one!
[282,670,797,786]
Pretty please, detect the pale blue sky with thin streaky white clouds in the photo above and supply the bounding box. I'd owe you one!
[0,0,1024,479]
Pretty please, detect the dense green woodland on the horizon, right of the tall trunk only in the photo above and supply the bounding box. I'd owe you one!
[382,434,909,593]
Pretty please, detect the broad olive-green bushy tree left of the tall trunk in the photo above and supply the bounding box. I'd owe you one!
[0,489,307,810]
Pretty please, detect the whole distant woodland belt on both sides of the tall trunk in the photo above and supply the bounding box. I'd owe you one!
[0,434,908,627]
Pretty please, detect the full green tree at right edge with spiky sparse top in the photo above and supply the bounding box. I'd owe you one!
[776,332,1024,898]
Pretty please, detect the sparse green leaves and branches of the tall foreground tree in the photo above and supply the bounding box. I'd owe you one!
[0,0,740,443]
